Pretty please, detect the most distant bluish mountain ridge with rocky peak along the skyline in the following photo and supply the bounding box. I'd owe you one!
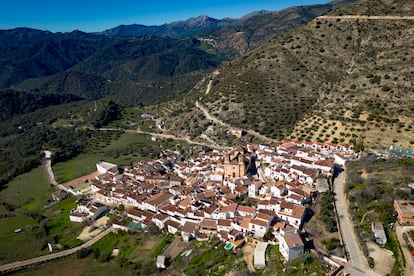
[99,0,355,54]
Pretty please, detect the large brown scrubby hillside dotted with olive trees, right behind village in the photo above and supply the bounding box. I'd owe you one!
[149,0,414,149]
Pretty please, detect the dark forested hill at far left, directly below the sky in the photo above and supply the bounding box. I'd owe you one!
[0,28,116,88]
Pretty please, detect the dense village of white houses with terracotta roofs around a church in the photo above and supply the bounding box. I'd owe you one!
[71,141,353,260]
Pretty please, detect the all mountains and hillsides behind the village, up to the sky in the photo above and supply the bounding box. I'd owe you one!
[0,0,414,187]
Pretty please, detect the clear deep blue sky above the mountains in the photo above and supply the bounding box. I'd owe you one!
[0,0,329,32]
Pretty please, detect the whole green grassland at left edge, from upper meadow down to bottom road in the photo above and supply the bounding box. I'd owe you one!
[0,166,54,263]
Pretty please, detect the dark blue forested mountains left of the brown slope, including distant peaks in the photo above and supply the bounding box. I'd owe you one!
[0,0,352,113]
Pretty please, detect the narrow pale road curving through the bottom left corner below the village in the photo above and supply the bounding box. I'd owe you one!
[0,227,114,274]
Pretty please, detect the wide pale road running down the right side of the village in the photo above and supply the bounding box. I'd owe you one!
[333,171,379,275]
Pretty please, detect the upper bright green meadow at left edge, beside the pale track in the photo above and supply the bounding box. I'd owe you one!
[0,166,54,212]
